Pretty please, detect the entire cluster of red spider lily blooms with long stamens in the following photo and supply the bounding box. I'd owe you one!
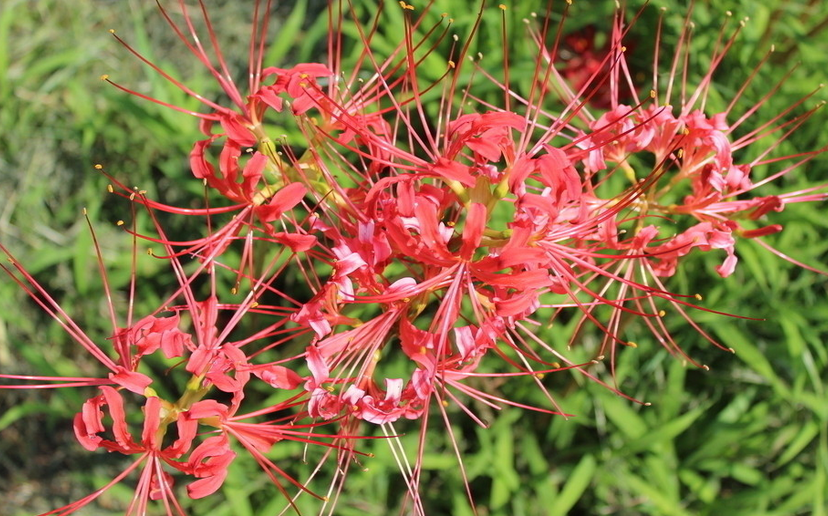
[0,2,825,514]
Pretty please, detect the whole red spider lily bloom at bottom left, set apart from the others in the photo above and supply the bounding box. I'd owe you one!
[0,203,346,514]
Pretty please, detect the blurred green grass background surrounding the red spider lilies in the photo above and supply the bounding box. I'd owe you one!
[0,0,828,516]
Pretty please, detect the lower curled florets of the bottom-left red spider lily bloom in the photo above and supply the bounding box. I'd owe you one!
[58,386,352,514]
